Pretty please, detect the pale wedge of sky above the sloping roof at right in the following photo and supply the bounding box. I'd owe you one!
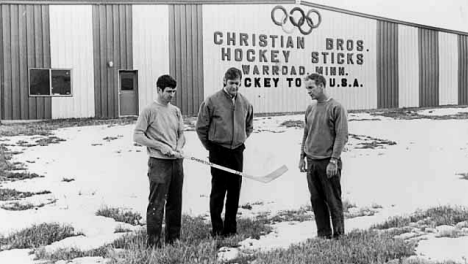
[304,0,468,32]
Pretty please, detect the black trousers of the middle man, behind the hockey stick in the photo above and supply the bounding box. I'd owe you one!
[210,144,245,236]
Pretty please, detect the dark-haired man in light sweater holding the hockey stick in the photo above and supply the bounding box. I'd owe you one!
[133,75,185,247]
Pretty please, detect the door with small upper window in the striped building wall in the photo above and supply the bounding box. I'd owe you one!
[119,71,138,116]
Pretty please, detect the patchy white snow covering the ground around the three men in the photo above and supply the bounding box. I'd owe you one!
[0,108,468,263]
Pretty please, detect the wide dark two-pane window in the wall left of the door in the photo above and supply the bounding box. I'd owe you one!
[29,69,72,96]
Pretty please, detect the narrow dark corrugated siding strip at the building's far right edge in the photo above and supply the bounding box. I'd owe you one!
[458,36,468,105]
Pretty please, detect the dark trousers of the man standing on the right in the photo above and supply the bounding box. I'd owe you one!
[307,158,344,238]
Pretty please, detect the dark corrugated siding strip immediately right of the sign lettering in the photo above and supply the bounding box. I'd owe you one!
[377,21,399,108]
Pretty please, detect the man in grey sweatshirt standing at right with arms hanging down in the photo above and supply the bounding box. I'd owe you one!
[299,73,348,238]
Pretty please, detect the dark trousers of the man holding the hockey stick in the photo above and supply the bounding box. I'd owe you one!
[146,157,184,247]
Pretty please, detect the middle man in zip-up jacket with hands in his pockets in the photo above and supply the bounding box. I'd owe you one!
[196,68,253,237]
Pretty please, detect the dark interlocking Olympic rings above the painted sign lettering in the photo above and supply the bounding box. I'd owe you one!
[271,5,322,35]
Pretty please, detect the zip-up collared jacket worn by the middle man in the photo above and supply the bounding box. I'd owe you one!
[196,89,253,150]
